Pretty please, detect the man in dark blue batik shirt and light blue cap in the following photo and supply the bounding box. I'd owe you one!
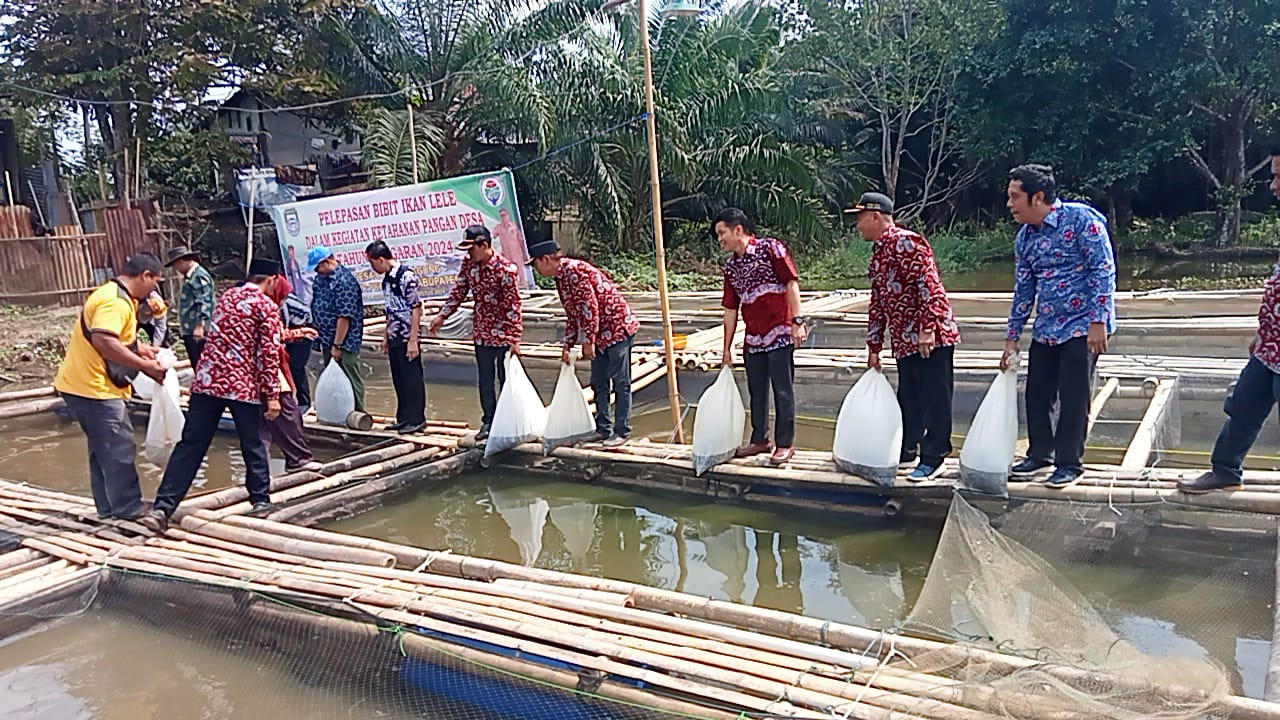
[307,246,365,413]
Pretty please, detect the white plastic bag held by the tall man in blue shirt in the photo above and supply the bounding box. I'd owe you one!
[960,355,1020,497]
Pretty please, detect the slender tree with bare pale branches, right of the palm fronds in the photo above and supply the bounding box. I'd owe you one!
[790,0,998,220]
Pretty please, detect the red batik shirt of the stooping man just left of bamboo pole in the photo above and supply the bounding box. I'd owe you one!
[556,258,640,351]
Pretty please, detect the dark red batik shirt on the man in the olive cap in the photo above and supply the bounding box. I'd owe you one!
[867,225,960,357]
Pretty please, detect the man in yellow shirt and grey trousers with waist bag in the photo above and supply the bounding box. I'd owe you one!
[54,252,165,520]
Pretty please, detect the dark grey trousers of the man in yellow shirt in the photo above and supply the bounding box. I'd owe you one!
[63,395,142,518]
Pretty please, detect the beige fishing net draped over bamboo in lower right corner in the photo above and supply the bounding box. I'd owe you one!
[900,493,1276,720]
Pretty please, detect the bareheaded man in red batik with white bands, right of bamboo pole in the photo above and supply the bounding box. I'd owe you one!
[712,208,809,465]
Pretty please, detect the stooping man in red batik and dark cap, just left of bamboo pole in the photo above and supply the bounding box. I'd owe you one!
[529,240,640,447]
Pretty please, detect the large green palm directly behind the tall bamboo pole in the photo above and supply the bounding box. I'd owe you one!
[536,1,827,250]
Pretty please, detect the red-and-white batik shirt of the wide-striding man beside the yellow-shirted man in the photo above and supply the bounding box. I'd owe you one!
[191,283,282,404]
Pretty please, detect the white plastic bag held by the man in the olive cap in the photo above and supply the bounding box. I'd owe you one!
[831,369,902,487]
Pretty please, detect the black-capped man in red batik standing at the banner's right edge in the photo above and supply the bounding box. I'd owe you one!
[430,225,525,441]
